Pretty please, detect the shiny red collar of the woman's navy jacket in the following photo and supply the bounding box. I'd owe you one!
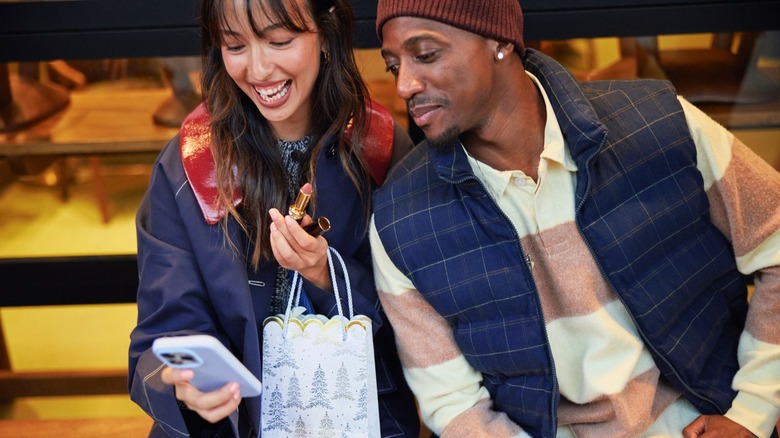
[179,101,394,225]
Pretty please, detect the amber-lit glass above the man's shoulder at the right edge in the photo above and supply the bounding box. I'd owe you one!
[528,31,780,169]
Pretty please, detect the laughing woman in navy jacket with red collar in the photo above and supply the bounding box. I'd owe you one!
[130,0,419,437]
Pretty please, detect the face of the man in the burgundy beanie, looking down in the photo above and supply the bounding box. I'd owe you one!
[382,17,495,146]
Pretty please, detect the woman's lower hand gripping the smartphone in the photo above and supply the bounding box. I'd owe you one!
[161,367,241,424]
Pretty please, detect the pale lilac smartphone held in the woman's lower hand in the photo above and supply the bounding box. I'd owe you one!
[152,335,263,397]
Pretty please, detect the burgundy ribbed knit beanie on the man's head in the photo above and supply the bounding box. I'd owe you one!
[376,0,525,55]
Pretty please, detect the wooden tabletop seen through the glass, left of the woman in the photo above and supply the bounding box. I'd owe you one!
[0,88,178,157]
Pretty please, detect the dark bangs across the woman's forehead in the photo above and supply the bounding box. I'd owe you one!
[210,0,316,46]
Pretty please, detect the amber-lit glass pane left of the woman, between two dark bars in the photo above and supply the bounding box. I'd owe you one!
[0,58,180,258]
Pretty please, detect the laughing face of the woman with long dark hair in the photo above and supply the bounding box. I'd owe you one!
[221,0,322,140]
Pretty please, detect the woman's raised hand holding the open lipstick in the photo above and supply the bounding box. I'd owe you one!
[268,208,331,291]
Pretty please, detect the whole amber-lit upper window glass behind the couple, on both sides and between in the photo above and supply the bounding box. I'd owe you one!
[0,32,780,257]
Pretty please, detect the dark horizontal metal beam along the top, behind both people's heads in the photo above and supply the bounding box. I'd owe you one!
[0,0,780,62]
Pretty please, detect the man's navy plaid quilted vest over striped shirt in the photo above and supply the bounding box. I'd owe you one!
[374,49,747,437]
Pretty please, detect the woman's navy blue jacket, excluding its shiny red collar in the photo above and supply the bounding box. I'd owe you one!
[129,126,419,437]
